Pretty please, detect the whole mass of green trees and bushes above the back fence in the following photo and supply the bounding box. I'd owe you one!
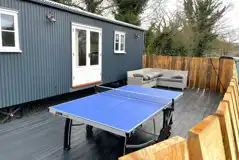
[145,0,228,57]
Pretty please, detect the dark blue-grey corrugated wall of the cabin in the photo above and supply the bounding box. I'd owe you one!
[0,0,144,108]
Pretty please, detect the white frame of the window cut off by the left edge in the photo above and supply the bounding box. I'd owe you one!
[0,8,22,52]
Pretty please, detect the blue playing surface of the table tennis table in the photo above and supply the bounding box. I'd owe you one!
[51,85,182,133]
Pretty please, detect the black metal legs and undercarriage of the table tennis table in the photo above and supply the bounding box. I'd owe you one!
[64,99,175,155]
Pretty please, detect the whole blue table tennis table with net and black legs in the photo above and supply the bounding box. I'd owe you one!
[49,85,183,154]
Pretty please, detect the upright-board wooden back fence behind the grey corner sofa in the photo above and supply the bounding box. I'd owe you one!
[143,55,234,93]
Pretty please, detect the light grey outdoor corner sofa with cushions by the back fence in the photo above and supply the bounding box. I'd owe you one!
[127,68,188,90]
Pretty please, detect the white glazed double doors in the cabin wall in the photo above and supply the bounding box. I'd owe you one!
[72,23,102,88]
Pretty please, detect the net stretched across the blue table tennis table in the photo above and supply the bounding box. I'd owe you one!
[96,86,172,105]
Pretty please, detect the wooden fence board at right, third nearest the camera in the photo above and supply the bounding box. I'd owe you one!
[216,101,238,160]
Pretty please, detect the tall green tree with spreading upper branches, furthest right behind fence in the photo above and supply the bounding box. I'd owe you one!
[184,0,228,57]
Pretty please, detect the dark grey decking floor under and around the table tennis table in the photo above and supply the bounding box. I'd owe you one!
[0,89,222,160]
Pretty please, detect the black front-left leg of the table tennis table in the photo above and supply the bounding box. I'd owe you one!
[64,118,72,150]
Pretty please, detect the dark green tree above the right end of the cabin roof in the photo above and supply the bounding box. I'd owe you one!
[113,0,148,25]
